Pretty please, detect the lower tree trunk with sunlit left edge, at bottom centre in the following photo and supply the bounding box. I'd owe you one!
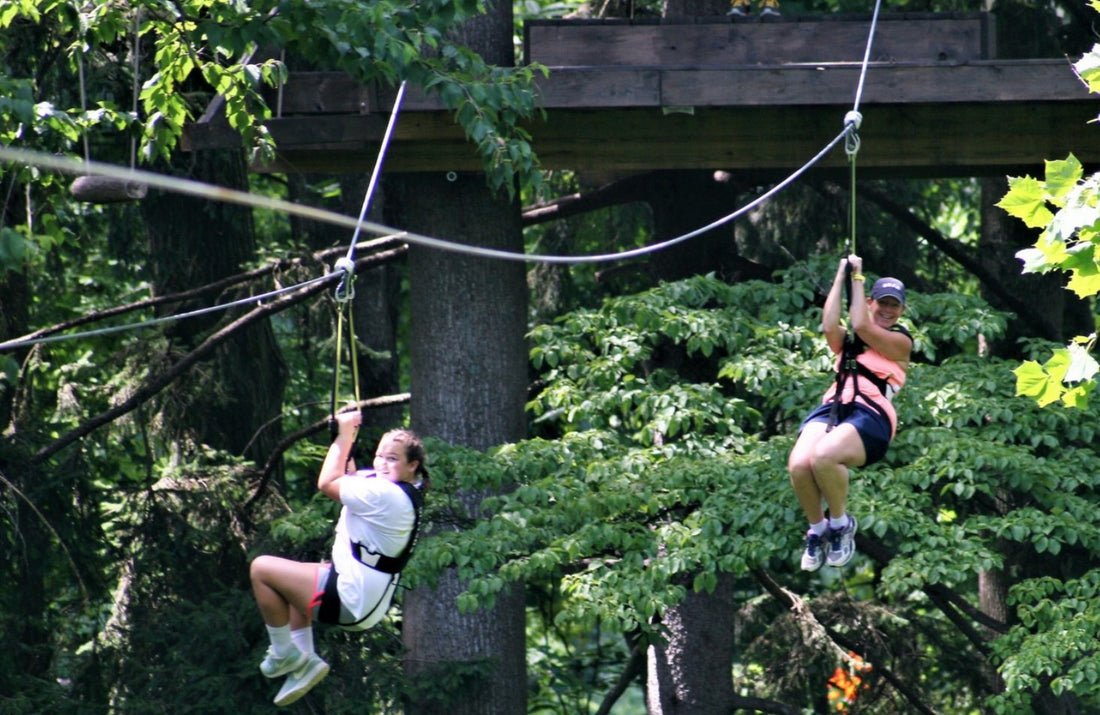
[646,574,737,715]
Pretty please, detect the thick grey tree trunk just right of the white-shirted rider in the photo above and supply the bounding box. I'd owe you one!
[392,168,527,715]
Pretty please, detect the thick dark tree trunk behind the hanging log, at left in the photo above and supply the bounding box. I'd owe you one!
[141,152,286,462]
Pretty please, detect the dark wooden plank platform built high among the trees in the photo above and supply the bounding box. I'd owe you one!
[187,13,1100,178]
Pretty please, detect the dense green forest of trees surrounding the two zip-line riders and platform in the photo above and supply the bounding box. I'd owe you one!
[0,0,1100,715]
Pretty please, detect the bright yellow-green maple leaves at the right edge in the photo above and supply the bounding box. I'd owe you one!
[998,11,1100,407]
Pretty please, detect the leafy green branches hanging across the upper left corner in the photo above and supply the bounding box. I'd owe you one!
[0,0,540,194]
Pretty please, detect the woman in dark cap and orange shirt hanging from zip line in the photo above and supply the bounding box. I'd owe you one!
[788,255,913,571]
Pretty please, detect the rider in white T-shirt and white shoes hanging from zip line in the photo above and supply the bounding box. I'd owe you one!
[250,410,430,705]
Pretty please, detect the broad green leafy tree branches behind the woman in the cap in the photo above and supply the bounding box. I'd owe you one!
[400,270,1100,712]
